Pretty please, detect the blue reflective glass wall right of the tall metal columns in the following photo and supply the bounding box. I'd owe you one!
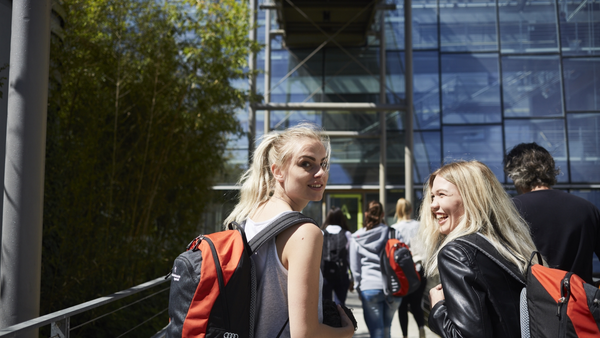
[386,0,600,205]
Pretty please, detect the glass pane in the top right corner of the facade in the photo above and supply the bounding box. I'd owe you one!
[558,0,600,55]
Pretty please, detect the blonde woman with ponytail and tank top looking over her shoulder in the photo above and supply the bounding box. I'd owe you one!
[224,124,354,338]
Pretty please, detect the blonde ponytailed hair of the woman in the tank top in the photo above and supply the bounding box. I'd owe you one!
[223,123,331,227]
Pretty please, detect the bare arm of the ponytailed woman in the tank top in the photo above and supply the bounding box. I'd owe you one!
[277,223,354,338]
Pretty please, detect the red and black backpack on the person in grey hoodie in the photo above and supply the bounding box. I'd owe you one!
[379,227,421,297]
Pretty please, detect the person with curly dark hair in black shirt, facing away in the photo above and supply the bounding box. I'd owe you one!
[504,143,600,283]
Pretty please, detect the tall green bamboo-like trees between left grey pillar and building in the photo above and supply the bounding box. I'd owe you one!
[41,0,257,336]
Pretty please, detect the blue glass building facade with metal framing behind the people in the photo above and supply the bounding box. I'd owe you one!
[207,0,600,232]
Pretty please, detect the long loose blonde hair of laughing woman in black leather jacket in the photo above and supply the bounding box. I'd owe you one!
[420,161,536,275]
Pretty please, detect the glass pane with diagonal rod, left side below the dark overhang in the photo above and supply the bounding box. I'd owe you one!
[268,50,323,102]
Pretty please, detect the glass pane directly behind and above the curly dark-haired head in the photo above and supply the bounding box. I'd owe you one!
[504,119,569,183]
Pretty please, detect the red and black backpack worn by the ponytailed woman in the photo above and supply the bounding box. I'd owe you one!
[167,212,316,338]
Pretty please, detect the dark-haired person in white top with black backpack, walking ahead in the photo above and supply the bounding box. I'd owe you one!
[321,207,352,305]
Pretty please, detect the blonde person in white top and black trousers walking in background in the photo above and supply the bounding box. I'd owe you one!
[392,198,427,338]
